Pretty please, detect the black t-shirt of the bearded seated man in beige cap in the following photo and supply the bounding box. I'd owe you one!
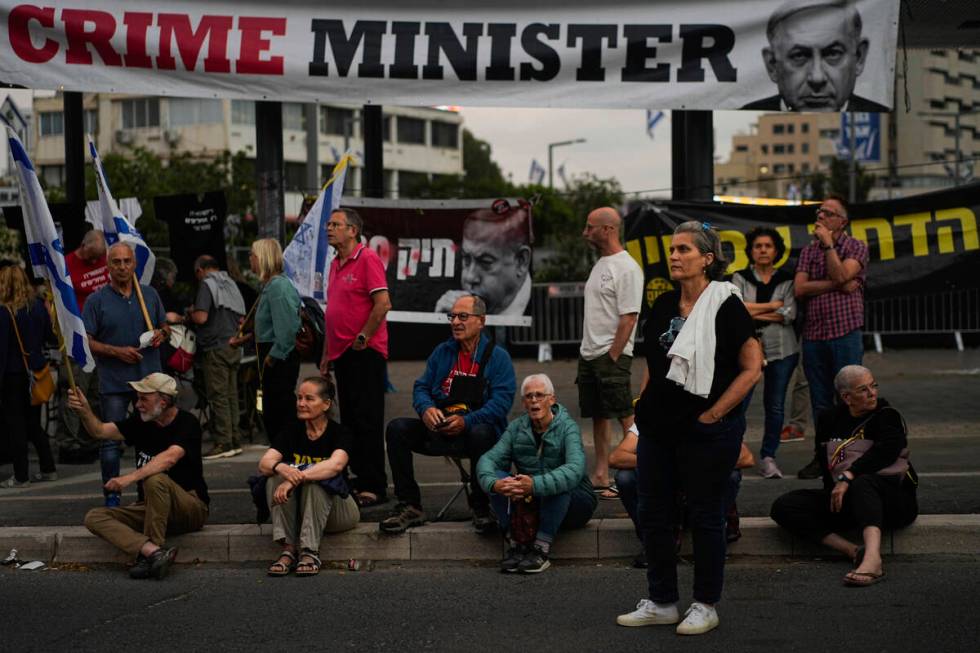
[116,410,211,503]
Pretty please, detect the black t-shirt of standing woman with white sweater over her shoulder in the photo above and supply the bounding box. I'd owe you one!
[636,290,754,437]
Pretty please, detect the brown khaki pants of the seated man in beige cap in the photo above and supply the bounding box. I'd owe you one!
[85,473,208,558]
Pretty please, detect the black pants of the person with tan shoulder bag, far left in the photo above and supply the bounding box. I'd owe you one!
[0,374,55,483]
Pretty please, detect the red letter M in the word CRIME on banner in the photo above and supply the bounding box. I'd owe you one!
[157,14,234,73]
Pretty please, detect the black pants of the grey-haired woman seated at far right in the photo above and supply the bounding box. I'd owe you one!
[769,474,919,542]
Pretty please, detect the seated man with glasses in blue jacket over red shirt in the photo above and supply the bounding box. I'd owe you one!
[378,295,516,533]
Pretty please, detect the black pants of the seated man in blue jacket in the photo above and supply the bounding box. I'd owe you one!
[385,417,498,510]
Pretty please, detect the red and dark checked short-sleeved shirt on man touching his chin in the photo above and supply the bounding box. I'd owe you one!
[796,234,868,340]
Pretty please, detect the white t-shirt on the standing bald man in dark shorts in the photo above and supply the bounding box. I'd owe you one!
[579,250,643,360]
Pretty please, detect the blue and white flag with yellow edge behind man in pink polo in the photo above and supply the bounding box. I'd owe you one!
[282,152,353,307]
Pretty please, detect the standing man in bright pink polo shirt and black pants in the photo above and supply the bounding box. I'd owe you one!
[320,209,391,507]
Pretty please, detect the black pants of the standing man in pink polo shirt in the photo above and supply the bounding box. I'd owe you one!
[333,347,388,497]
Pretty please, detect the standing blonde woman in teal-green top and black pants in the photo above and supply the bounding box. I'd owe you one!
[232,238,300,441]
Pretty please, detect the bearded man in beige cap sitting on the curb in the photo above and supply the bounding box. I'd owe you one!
[68,372,209,579]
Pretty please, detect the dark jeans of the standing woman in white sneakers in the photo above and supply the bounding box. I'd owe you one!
[636,415,745,604]
